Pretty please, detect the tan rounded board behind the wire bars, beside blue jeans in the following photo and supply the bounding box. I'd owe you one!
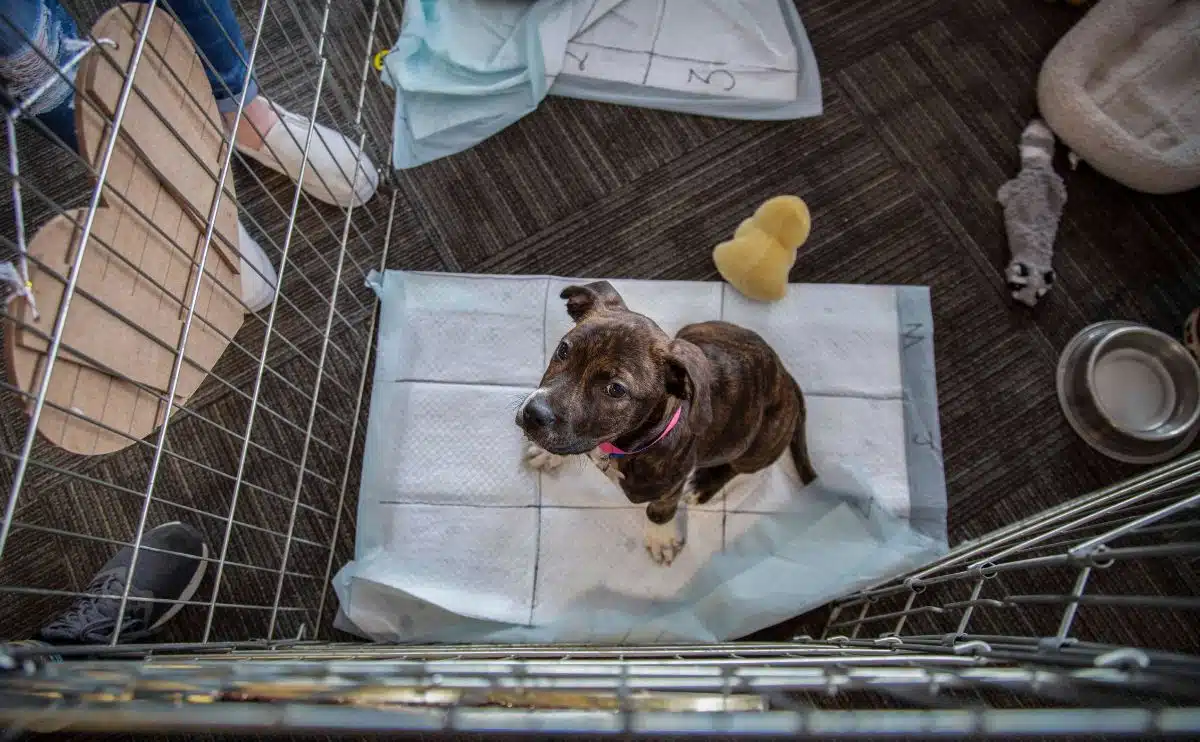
[5,4,242,454]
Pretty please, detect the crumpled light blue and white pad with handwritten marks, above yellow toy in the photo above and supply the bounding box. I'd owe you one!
[383,0,821,168]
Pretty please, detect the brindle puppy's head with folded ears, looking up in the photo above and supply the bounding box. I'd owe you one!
[516,281,709,455]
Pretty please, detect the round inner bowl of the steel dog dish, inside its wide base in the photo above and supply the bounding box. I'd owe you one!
[1086,325,1200,442]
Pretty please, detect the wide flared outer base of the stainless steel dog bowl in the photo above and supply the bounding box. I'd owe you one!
[1057,321,1198,463]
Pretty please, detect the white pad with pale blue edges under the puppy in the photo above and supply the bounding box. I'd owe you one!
[334,271,946,642]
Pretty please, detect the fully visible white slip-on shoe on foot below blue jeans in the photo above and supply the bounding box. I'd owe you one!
[238,102,379,207]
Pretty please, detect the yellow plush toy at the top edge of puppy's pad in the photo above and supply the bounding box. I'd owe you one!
[713,196,812,301]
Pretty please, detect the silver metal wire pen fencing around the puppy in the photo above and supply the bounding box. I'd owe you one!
[0,0,1200,737]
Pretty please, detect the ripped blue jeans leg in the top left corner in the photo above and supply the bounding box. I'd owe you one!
[0,0,88,149]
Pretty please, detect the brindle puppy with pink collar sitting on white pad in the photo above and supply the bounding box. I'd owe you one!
[516,281,816,564]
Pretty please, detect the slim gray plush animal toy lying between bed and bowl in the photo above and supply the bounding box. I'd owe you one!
[996,119,1067,306]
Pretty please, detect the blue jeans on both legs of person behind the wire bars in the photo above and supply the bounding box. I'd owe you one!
[0,0,258,149]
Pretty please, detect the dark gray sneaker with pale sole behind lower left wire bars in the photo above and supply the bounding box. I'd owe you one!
[38,521,209,644]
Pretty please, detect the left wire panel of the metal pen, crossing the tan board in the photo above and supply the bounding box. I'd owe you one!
[0,1,400,641]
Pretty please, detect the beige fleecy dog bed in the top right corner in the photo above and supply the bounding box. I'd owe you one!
[1038,0,1200,193]
